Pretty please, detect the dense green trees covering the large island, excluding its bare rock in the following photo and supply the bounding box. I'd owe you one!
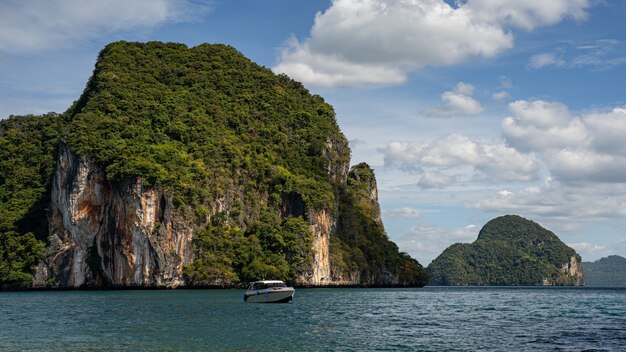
[0,42,426,287]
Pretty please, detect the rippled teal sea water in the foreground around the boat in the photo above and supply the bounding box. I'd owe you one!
[0,287,626,351]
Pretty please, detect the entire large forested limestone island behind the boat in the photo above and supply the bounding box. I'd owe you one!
[0,42,428,289]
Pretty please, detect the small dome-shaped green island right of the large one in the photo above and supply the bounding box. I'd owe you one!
[427,215,584,286]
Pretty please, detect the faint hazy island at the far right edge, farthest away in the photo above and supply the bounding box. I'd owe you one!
[583,255,626,287]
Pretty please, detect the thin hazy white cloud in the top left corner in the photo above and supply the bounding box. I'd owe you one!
[0,0,208,53]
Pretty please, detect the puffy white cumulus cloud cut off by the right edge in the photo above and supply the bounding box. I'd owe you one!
[502,100,626,183]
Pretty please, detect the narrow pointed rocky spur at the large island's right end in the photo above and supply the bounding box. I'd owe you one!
[331,163,428,286]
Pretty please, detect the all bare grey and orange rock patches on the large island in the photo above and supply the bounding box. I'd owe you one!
[34,136,390,288]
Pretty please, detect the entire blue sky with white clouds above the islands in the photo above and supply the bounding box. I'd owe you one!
[0,0,626,265]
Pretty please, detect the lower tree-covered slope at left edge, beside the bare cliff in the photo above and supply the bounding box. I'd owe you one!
[0,113,65,288]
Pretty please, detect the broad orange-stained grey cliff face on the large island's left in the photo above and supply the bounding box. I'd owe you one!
[40,143,194,287]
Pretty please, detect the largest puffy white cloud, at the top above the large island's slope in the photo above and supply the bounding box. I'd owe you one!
[274,0,590,86]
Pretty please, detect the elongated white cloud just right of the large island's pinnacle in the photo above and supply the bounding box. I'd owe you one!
[381,134,539,184]
